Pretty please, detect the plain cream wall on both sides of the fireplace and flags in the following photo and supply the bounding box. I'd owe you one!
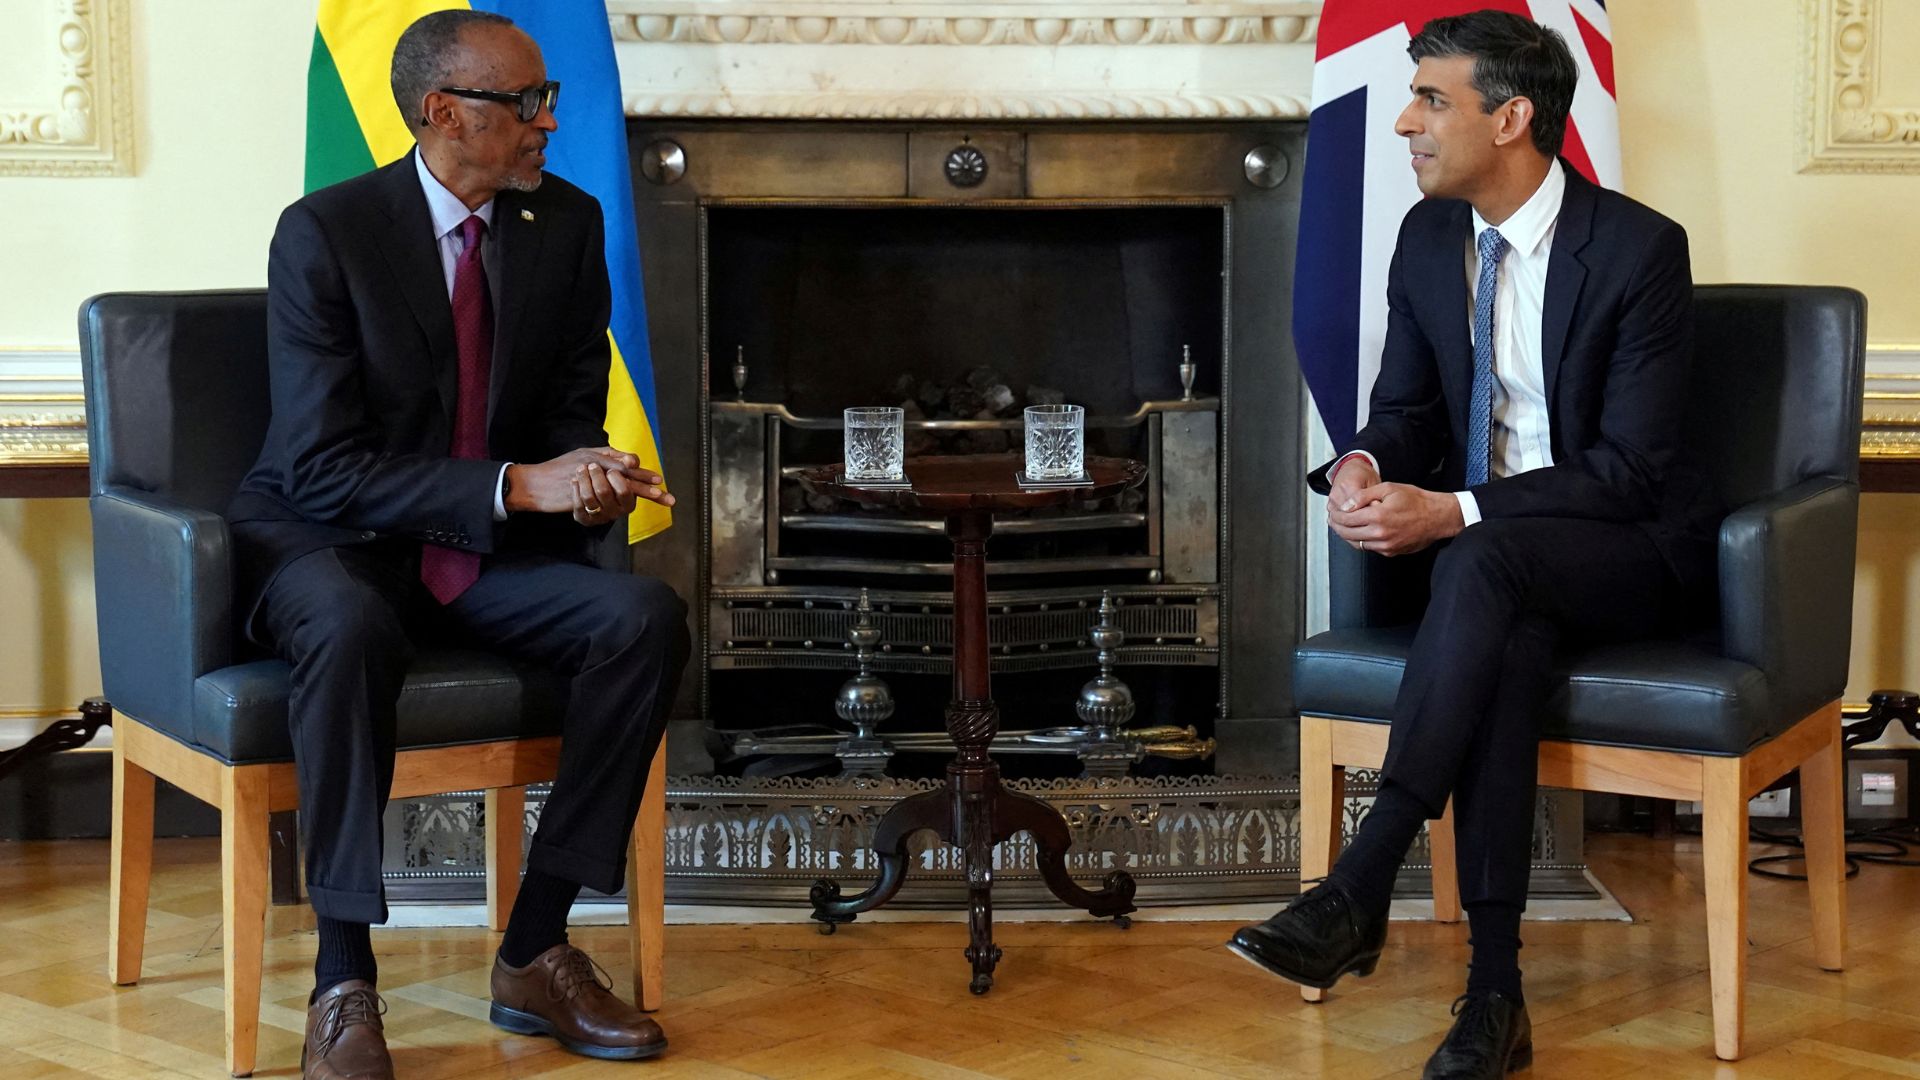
[0,0,1920,707]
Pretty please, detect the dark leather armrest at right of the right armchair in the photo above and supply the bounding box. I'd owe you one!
[1720,477,1860,711]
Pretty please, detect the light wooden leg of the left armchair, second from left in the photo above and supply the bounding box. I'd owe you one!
[221,765,267,1076]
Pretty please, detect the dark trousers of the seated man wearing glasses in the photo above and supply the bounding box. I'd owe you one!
[255,544,689,922]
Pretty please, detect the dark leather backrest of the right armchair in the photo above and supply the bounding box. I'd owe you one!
[1688,284,1866,509]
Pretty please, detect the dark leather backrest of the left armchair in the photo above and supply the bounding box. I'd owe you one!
[81,288,269,513]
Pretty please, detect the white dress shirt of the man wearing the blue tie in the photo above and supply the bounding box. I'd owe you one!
[1329,161,1567,525]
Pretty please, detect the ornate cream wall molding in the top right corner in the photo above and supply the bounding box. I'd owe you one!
[1799,0,1920,173]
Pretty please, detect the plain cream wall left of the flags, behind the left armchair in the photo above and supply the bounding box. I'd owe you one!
[0,0,313,711]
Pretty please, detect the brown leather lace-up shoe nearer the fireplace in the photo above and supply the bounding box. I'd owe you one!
[488,944,666,1061]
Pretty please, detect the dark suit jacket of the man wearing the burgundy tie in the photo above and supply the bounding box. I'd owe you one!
[227,154,611,611]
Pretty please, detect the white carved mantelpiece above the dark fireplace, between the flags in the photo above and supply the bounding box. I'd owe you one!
[607,0,1321,119]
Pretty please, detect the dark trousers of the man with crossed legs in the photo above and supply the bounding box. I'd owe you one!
[1382,517,1711,907]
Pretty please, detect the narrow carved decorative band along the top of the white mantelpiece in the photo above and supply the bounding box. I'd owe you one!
[607,0,1319,46]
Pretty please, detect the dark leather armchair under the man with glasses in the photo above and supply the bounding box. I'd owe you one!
[81,290,666,1076]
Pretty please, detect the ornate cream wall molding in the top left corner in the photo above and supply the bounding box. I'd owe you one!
[0,0,132,177]
